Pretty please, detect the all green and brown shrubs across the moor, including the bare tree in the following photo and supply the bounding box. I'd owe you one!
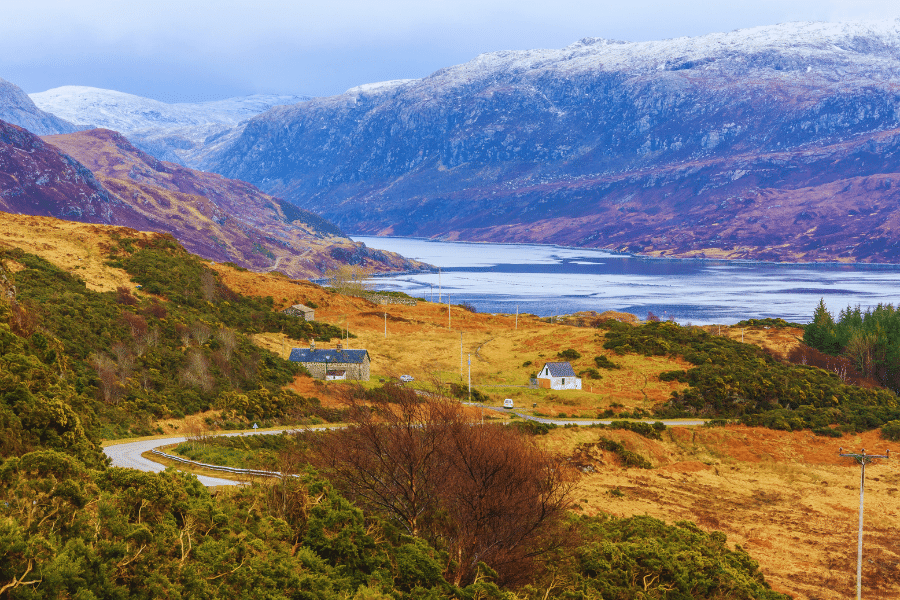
[0,230,884,600]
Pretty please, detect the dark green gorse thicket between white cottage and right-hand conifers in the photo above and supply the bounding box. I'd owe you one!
[604,323,900,431]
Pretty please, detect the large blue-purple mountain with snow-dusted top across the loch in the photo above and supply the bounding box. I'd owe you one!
[203,20,900,262]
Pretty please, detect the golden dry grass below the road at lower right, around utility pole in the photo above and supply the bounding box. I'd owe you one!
[547,426,900,599]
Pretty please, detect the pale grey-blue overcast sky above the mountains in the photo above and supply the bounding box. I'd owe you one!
[0,0,900,102]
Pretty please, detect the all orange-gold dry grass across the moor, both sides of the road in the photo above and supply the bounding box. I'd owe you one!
[0,215,900,600]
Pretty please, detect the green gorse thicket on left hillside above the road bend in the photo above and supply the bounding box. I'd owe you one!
[0,237,348,446]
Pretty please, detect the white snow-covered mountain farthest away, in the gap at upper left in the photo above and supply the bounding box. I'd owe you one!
[30,85,309,164]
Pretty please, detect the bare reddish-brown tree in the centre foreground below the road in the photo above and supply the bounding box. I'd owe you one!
[300,384,571,585]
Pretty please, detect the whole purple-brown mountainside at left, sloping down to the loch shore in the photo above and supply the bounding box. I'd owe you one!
[0,121,424,277]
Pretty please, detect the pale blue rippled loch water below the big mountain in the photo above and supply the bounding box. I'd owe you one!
[353,236,900,325]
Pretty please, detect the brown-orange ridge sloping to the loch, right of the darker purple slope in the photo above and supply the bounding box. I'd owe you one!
[45,129,423,277]
